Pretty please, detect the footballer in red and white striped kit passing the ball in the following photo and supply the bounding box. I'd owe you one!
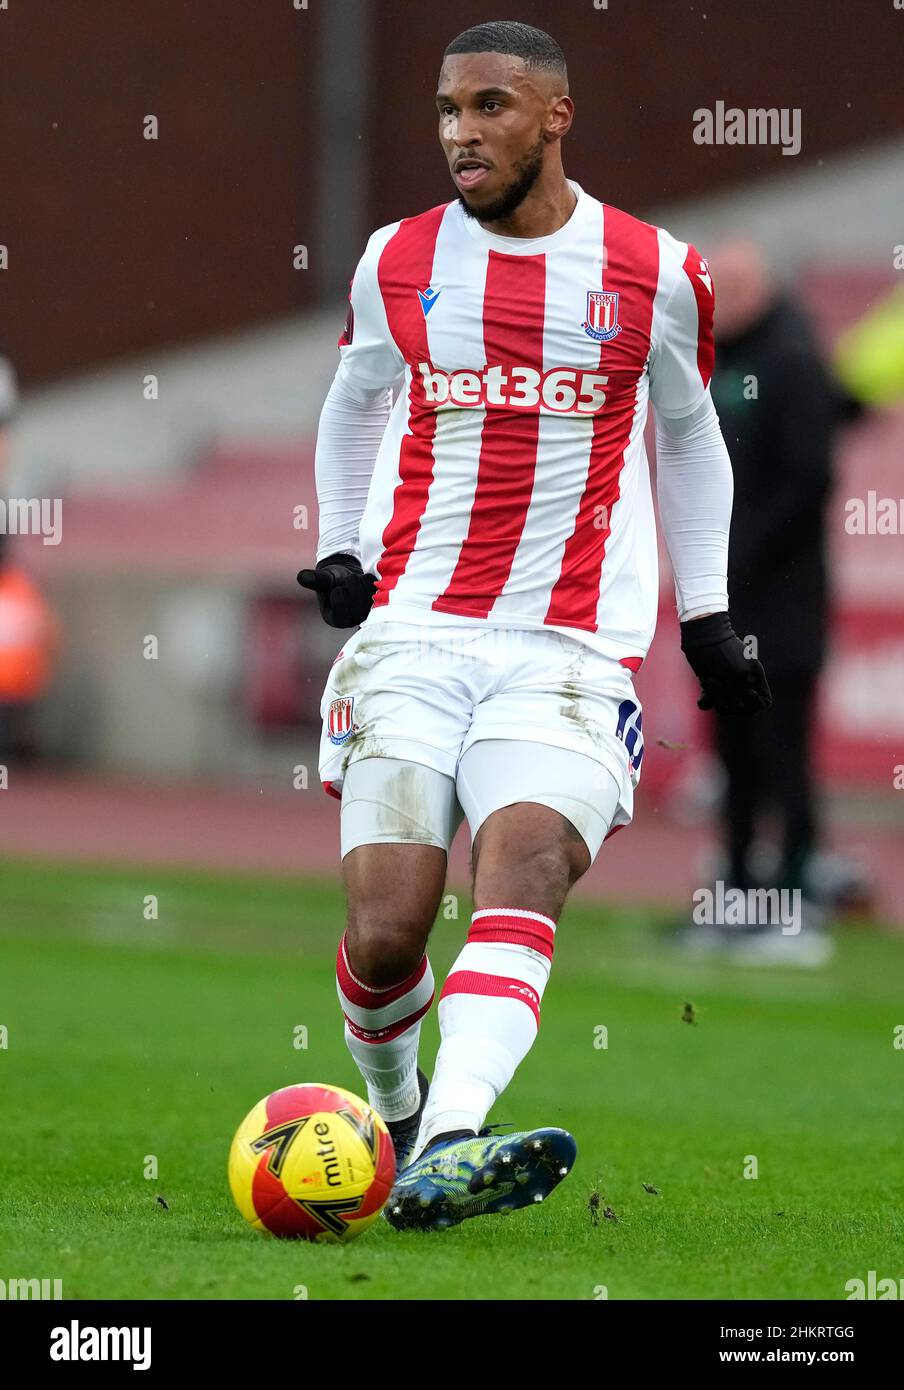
[299,21,770,1229]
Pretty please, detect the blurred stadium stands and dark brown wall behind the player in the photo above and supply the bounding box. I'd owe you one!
[0,0,904,926]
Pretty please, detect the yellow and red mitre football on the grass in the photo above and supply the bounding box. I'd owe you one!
[229,1083,395,1244]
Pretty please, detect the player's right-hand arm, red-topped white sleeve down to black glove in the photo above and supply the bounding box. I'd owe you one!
[649,246,772,714]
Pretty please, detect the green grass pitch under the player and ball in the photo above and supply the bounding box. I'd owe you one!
[0,865,904,1300]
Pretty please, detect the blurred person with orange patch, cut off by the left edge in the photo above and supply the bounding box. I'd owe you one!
[0,354,57,763]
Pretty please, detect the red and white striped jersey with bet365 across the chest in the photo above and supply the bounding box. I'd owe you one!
[326,181,713,664]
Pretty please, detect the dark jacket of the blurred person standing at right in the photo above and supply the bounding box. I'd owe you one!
[712,300,843,676]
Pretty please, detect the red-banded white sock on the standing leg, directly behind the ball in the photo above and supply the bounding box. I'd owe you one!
[337,935,434,1120]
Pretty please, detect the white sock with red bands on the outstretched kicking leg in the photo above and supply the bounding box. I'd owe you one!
[416,908,555,1152]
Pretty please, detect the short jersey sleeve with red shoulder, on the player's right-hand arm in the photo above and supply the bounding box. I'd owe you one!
[649,246,715,418]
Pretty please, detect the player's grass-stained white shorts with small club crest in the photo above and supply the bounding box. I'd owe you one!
[320,621,643,853]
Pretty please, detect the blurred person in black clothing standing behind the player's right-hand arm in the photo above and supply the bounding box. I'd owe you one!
[698,239,859,963]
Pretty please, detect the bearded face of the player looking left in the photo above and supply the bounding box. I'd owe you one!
[437,53,549,221]
